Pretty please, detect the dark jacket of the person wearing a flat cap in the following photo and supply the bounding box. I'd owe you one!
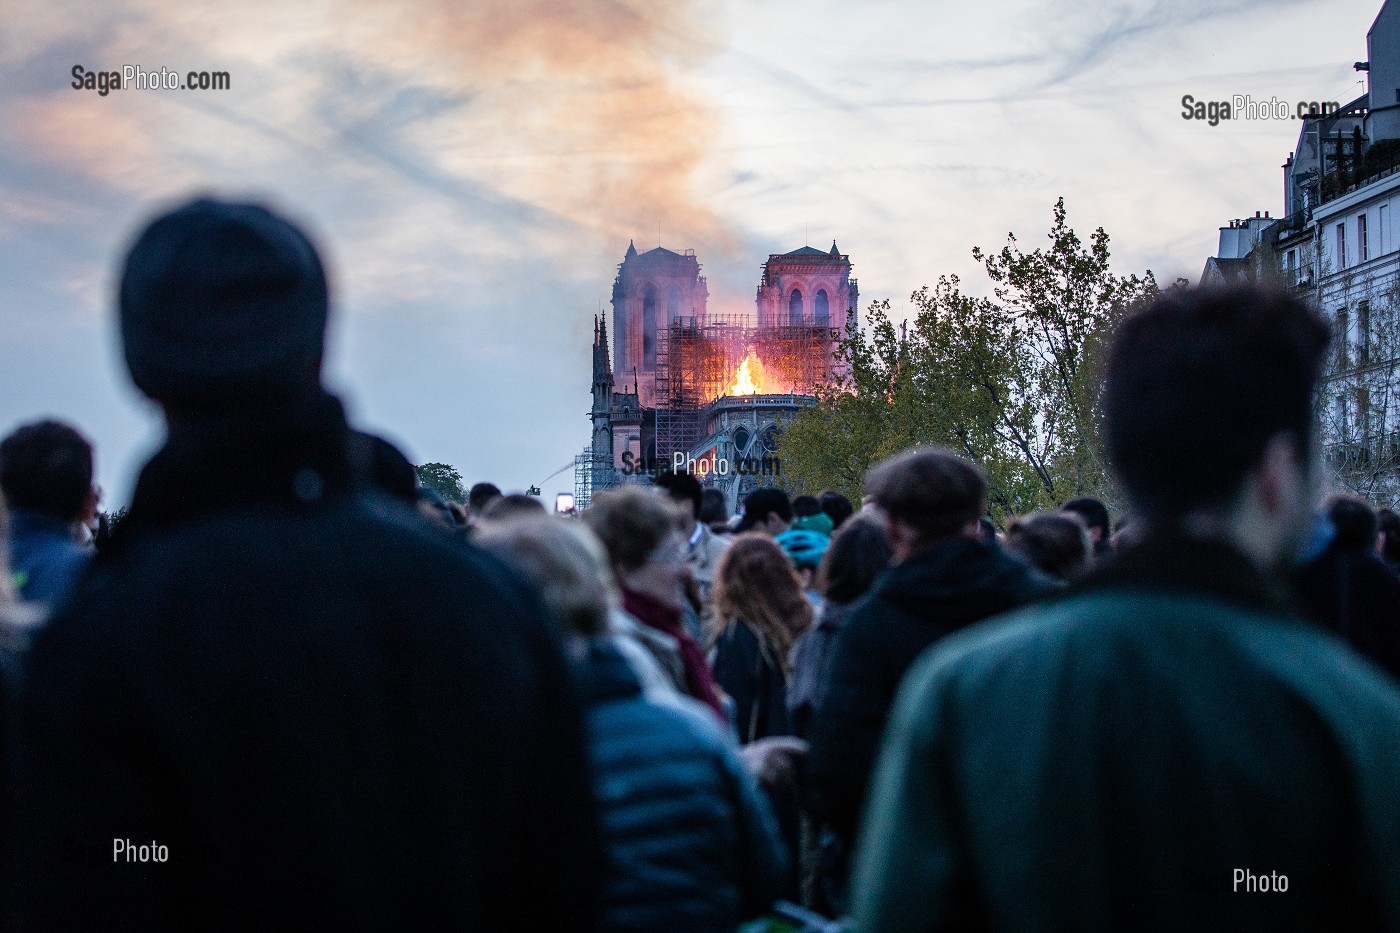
[808,537,1054,842]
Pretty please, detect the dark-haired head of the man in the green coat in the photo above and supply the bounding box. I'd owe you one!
[1103,284,1329,563]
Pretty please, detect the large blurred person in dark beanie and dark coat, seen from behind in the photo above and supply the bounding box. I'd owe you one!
[3,200,601,930]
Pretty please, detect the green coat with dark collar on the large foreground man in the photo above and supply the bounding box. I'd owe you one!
[851,542,1400,933]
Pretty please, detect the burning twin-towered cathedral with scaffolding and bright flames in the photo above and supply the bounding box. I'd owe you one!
[574,242,860,511]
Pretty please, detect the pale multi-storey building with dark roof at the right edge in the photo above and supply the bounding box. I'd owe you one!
[1201,0,1400,506]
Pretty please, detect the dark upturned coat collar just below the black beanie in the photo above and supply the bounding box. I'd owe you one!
[118,394,367,538]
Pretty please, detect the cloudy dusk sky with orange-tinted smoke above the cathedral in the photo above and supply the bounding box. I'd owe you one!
[0,0,1380,509]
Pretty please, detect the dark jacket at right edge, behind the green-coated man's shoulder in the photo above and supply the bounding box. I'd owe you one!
[1292,541,1400,681]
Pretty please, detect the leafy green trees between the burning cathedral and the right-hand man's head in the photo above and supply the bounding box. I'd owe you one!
[780,198,1164,517]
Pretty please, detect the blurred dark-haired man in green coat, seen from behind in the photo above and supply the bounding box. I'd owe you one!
[853,282,1400,930]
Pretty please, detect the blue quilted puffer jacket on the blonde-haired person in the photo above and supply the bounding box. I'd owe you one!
[582,643,785,933]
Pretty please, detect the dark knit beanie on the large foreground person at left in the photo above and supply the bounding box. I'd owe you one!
[120,199,328,409]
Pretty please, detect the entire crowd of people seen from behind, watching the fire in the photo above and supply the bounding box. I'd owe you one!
[0,199,1400,933]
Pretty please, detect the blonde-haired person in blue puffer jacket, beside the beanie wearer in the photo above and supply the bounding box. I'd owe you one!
[477,516,785,933]
